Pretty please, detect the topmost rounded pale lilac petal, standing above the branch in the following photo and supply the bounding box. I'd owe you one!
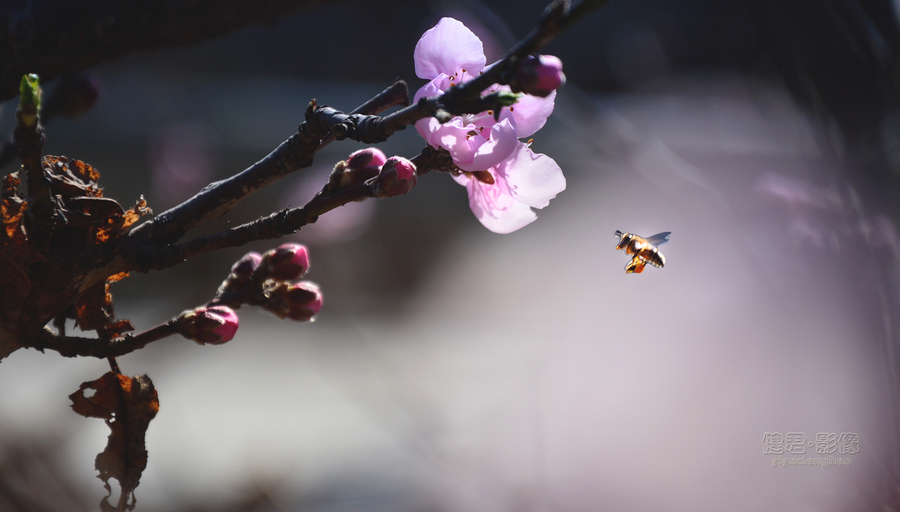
[413,18,486,80]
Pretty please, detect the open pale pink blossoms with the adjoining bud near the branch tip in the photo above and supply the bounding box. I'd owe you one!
[415,18,566,233]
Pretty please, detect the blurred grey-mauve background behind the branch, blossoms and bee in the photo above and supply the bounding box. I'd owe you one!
[0,0,900,512]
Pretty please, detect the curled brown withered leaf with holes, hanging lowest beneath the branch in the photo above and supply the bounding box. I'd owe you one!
[69,372,159,511]
